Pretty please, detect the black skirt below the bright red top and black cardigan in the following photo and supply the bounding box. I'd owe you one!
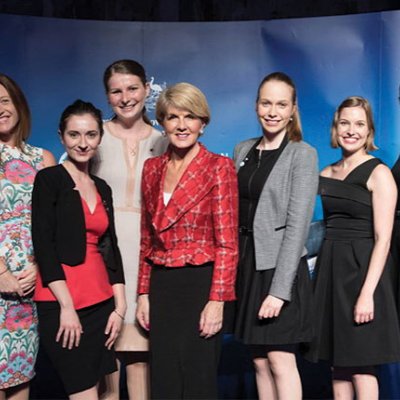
[37,298,117,395]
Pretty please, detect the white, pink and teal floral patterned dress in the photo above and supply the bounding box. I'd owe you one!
[0,144,43,389]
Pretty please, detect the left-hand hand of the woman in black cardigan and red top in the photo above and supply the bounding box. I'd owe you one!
[56,307,83,350]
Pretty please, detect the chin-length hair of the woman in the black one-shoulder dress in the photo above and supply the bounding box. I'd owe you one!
[331,96,378,151]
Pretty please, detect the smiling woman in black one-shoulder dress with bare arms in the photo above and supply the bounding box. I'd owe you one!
[312,97,400,400]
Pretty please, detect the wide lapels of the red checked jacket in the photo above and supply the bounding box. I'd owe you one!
[144,144,217,232]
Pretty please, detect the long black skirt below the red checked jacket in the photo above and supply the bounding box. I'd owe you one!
[149,264,221,400]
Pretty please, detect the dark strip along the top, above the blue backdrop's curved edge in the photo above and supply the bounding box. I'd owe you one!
[0,0,400,21]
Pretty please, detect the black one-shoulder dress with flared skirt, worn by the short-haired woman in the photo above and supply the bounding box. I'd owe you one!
[311,158,400,367]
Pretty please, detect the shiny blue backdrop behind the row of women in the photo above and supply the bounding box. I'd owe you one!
[0,11,400,398]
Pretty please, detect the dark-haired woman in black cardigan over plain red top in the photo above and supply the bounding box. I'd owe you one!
[32,100,126,400]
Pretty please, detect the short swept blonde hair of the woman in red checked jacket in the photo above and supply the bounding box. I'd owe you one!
[156,82,211,125]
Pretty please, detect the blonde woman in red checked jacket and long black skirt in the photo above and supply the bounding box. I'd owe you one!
[137,83,238,399]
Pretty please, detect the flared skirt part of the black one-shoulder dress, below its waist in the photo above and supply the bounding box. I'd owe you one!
[307,233,400,367]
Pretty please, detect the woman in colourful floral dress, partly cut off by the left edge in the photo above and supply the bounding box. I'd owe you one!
[0,74,55,400]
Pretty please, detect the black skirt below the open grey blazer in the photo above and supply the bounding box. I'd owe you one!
[235,235,313,345]
